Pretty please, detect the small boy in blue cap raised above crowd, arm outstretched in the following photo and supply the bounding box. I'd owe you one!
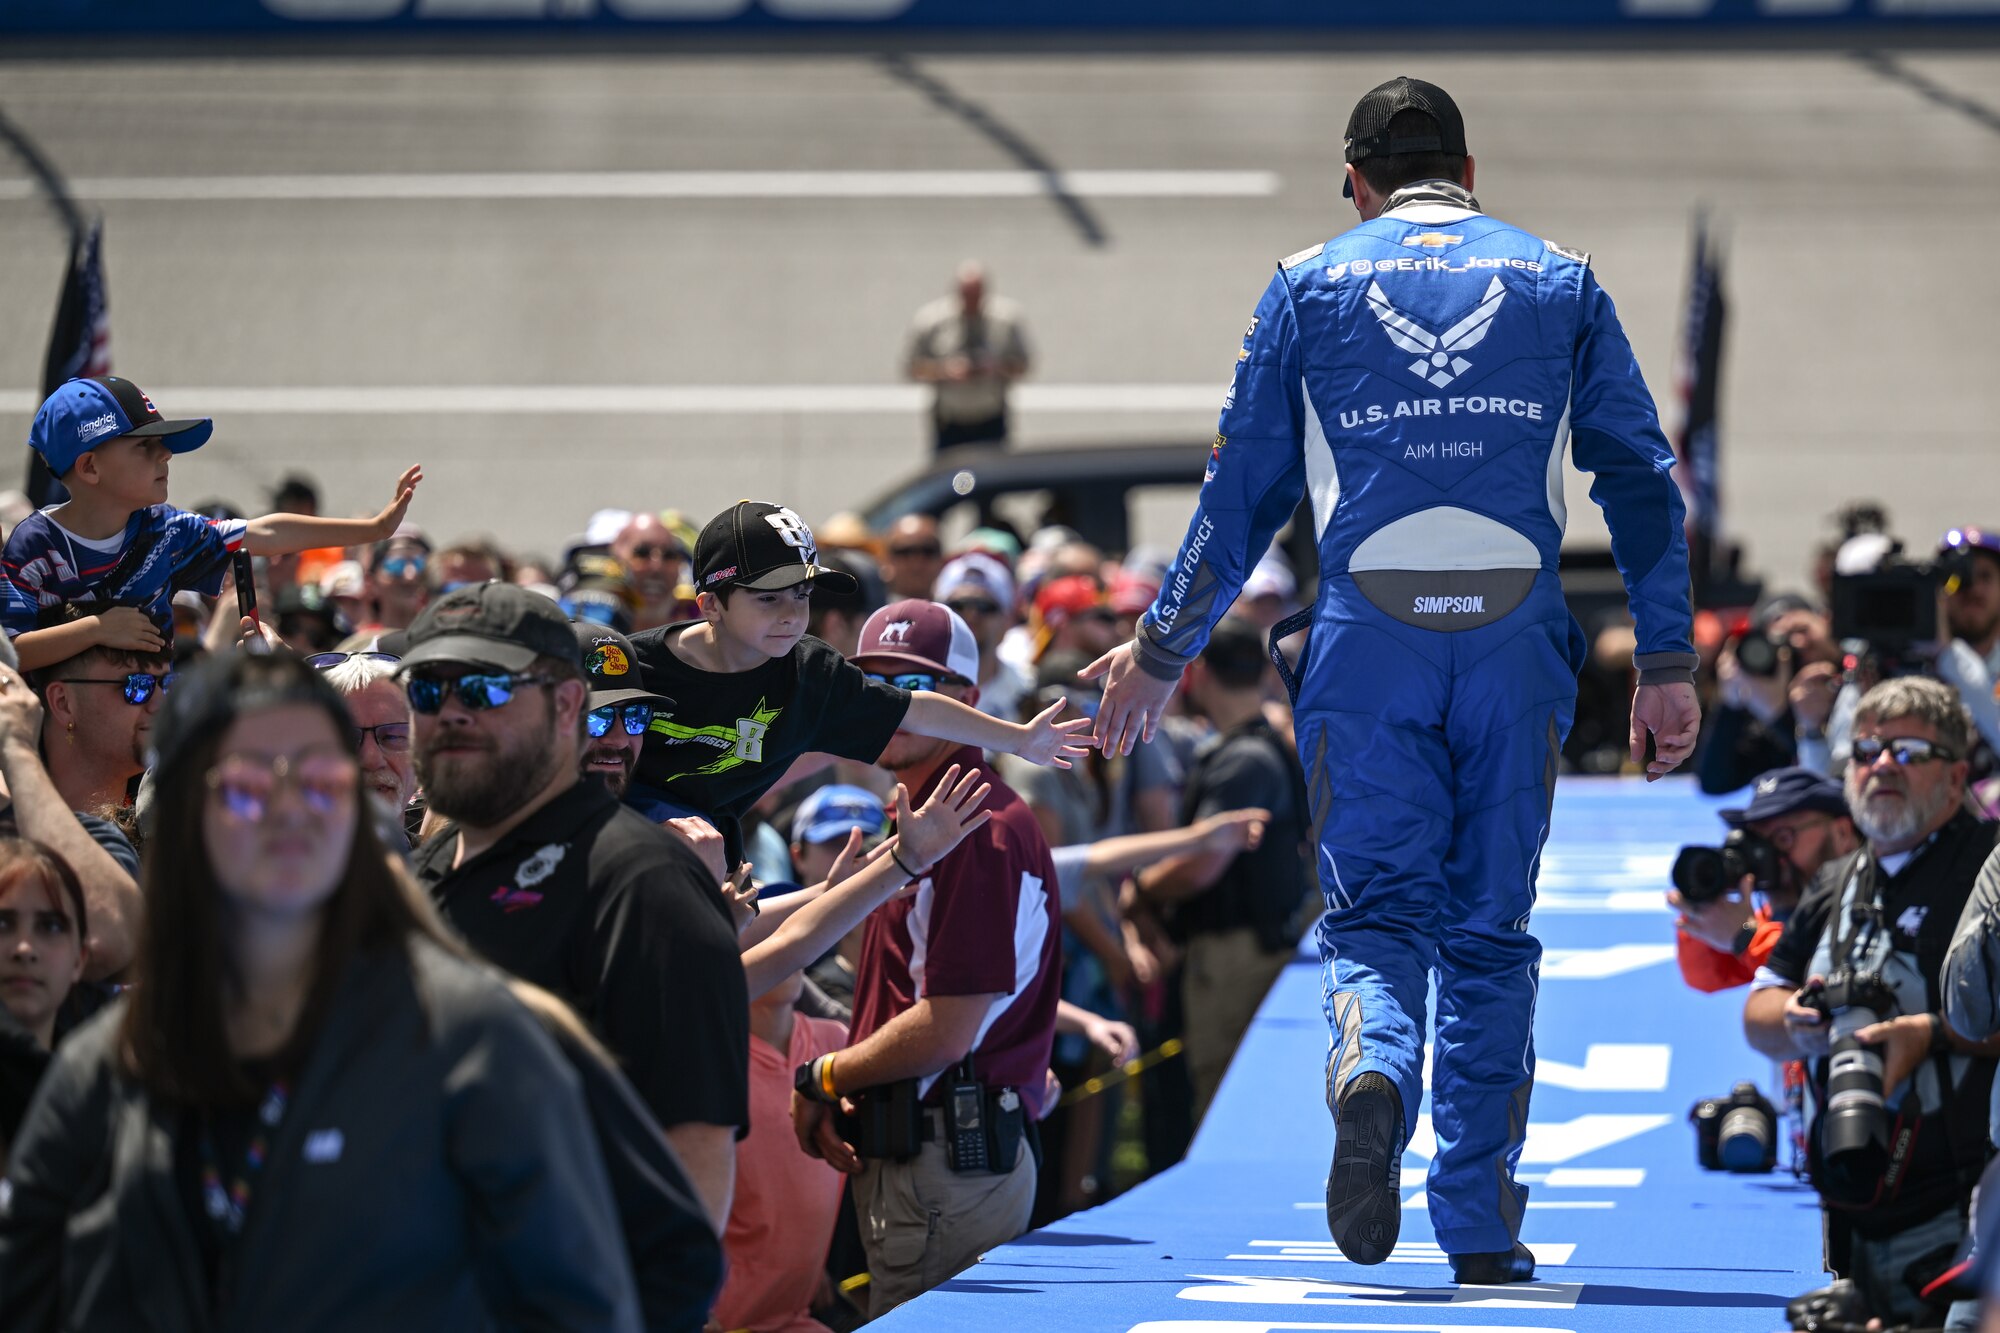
[0,374,424,671]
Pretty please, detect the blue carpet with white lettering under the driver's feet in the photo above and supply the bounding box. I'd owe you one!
[876,779,1826,1333]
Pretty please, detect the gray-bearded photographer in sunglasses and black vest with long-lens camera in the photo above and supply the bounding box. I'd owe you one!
[1744,677,2000,1321]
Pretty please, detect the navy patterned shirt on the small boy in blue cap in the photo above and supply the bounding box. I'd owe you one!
[0,504,248,638]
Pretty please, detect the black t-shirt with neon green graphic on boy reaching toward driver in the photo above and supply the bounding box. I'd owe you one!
[632,624,910,861]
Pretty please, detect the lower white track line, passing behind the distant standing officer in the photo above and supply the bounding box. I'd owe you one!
[0,382,1224,416]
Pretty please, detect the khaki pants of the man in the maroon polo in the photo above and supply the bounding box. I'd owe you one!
[854,1137,1034,1319]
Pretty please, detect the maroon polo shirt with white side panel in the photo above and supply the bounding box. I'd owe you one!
[848,747,1062,1115]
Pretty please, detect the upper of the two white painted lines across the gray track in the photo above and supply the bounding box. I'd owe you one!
[0,170,1282,204]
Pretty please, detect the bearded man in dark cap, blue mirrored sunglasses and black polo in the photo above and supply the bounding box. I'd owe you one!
[402,582,750,1231]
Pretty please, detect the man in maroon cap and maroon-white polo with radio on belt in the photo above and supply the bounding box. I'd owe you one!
[792,600,1062,1315]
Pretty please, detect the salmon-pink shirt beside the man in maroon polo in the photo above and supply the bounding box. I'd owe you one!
[712,1015,848,1333]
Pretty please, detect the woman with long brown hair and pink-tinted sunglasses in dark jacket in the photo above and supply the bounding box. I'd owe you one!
[0,654,638,1333]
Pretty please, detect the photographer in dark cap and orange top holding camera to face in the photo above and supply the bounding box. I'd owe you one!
[1666,769,1860,991]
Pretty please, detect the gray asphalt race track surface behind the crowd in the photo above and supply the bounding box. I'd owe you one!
[0,48,2000,584]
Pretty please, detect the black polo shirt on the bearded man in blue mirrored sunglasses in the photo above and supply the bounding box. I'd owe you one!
[412,779,750,1129]
